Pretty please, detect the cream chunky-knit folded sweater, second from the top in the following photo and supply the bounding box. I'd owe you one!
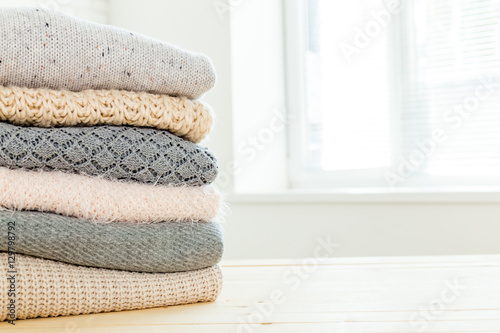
[0,84,213,143]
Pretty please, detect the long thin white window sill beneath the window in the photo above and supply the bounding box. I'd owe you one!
[228,188,500,204]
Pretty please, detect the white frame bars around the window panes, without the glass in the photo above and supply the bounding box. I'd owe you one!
[283,0,500,192]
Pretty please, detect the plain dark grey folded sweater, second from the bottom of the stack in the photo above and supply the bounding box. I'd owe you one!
[0,211,223,273]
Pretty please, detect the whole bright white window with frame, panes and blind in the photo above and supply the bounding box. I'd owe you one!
[285,0,500,188]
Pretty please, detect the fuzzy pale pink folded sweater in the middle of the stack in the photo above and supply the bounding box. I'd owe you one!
[0,167,222,223]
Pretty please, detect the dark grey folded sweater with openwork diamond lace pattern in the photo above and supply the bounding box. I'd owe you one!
[0,123,217,186]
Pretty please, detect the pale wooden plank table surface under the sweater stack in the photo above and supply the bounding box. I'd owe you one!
[0,255,500,333]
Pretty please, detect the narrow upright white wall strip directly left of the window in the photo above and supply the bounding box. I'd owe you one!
[230,0,288,193]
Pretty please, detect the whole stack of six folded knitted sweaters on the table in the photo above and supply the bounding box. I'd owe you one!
[0,8,223,321]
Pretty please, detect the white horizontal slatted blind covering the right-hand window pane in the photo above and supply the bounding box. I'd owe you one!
[399,0,500,176]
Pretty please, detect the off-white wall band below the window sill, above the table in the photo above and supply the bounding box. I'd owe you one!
[226,198,500,259]
